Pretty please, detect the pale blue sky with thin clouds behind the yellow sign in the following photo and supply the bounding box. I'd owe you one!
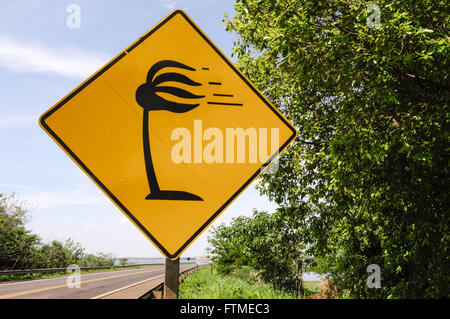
[0,0,276,257]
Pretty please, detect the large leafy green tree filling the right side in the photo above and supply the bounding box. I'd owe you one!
[225,0,450,298]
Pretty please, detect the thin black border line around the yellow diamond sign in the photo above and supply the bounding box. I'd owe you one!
[40,10,297,259]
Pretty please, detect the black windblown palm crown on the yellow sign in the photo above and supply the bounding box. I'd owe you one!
[136,60,205,113]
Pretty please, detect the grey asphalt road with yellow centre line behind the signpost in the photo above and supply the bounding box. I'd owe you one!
[0,265,192,299]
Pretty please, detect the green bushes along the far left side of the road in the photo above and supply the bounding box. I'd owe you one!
[0,194,127,280]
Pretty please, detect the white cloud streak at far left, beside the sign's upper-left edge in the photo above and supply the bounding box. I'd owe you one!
[0,35,109,78]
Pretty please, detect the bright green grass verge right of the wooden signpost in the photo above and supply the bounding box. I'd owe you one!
[179,266,302,299]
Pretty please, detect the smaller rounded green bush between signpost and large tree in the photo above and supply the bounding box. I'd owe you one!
[208,209,308,289]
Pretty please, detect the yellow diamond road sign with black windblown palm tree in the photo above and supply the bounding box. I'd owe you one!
[40,10,296,259]
